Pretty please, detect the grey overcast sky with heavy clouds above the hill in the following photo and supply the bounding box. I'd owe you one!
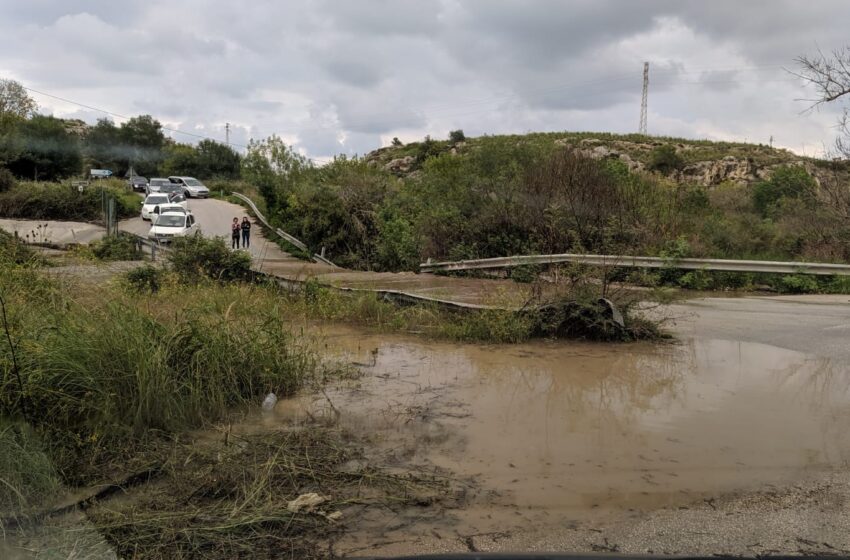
[0,0,850,160]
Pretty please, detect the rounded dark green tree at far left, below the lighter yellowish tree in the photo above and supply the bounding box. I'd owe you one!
[8,115,82,181]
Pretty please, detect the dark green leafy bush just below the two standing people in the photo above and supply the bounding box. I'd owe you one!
[168,233,251,282]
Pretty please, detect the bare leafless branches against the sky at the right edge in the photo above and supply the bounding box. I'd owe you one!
[791,46,850,159]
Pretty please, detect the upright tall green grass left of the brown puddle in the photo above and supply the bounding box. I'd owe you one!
[0,264,318,478]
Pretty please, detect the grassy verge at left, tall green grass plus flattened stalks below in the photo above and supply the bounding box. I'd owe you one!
[0,235,445,558]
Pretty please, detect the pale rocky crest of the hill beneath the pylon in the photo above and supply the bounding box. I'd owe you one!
[366,132,850,187]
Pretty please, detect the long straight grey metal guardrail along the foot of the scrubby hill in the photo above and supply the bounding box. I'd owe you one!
[419,253,850,276]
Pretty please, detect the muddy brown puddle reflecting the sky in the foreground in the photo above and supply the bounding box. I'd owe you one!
[283,330,850,524]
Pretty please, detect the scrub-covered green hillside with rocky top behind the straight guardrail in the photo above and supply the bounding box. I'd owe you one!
[243,133,850,278]
